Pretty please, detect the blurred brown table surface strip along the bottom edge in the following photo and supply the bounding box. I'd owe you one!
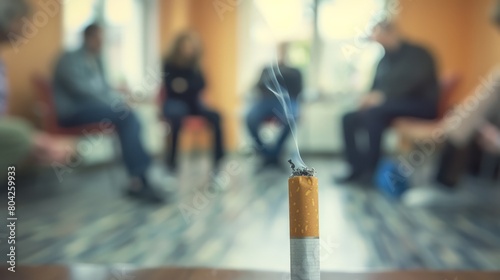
[0,265,500,280]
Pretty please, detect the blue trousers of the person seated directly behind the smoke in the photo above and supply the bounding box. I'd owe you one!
[246,97,298,161]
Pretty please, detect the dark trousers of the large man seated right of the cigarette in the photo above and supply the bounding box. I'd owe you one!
[342,100,437,174]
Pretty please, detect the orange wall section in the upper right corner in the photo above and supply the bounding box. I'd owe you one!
[398,0,500,103]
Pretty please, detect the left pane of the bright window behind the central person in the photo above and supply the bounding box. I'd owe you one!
[239,0,314,93]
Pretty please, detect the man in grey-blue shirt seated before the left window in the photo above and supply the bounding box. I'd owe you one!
[54,24,162,202]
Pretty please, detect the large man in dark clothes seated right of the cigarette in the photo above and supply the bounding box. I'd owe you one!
[336,20,439,183]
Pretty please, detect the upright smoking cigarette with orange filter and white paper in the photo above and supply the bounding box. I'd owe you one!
[288,160,320,280]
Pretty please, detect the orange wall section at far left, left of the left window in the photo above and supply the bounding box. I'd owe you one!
[2,0,62,120]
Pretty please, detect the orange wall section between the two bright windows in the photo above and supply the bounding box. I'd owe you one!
[160,0,239,149]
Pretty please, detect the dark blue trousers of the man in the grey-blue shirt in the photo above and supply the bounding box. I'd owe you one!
[59,103,151,177]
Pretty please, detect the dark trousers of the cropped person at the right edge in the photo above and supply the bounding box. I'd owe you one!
[436,139,500,187]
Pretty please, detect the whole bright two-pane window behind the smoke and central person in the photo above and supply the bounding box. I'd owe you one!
[240,0,388,96]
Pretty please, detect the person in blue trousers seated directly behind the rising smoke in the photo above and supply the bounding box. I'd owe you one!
[246,43,302,167]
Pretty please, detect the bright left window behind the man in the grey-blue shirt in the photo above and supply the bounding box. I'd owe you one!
[64,0,160,94]
